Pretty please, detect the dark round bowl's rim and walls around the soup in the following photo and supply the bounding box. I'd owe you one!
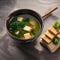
[6,9,43,43]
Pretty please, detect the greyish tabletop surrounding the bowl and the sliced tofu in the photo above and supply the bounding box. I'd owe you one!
[0,0,60,60]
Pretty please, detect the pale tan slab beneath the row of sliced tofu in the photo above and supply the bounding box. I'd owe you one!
[40,40,60,53]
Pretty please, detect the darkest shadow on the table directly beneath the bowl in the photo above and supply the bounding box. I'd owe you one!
[14,41,39,57]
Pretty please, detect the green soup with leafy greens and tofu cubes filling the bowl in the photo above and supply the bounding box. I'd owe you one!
[9,14,41,39]
